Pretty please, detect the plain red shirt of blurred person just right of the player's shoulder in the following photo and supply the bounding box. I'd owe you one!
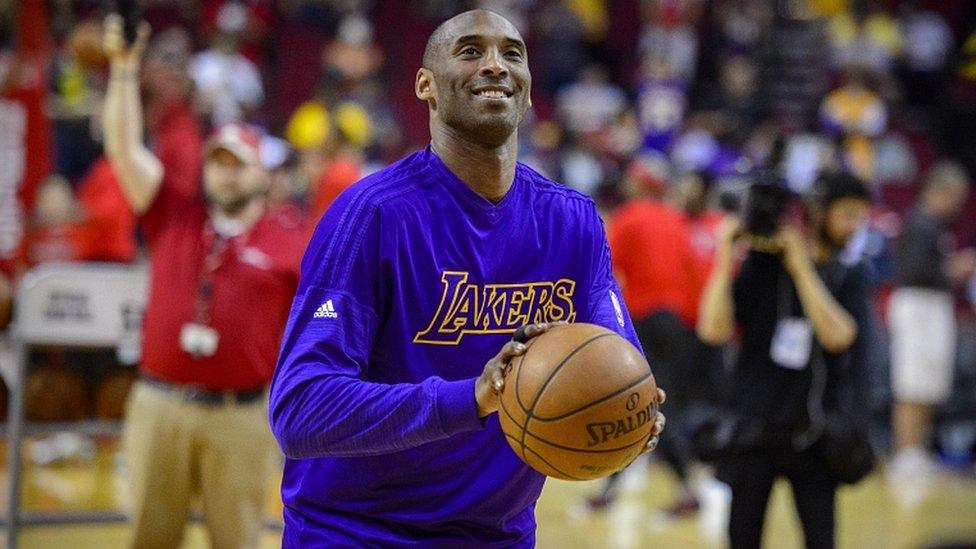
[607,199,694,324]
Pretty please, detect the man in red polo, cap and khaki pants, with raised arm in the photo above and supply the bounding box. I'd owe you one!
[104,16,306,547]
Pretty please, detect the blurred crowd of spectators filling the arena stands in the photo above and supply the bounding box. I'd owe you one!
[0,0,976,496]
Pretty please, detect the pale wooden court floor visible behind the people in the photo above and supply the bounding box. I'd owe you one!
[3,439,976,549]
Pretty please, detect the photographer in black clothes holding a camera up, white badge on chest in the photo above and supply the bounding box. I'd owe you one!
[698,174,871,548]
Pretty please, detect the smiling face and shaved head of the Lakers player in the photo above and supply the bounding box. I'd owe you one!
[417,11,532,146]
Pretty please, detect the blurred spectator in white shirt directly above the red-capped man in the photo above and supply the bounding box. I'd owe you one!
[189,2,264,127]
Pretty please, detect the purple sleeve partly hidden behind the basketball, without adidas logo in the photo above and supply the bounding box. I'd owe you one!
[586,203,644,353]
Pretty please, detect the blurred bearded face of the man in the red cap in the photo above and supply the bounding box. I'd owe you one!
[203,148,268,215]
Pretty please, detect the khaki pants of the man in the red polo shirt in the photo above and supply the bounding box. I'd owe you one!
[122,382,274,549]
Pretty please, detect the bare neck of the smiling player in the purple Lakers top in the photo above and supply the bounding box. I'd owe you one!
[430,124,518,203]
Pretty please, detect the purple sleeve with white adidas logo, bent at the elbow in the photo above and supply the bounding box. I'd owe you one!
[269,193,481,458]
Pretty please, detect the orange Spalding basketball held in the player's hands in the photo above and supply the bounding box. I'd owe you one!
[499,323,657,480]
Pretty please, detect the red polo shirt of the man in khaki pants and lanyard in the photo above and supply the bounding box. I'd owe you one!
[141,103,306,390]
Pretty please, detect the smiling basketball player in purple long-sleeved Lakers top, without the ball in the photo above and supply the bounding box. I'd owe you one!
[270,10,664,547]
